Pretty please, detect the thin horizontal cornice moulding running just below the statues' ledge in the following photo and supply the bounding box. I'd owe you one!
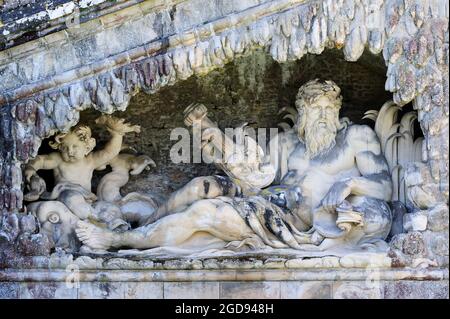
[0,268,449,282]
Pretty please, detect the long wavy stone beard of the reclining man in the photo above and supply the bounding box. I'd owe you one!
[305,122,337,158]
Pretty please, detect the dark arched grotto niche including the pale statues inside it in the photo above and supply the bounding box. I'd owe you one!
[24,50,431,263]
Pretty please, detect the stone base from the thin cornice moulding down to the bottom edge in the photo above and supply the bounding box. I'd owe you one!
[0,269,449,299]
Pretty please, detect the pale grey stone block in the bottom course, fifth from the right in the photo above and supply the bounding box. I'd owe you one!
[164,282,219,299]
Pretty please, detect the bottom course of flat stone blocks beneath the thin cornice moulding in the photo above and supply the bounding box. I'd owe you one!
[0,280,449,299]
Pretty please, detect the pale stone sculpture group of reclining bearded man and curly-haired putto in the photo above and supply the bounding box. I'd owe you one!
[25,80,426,254]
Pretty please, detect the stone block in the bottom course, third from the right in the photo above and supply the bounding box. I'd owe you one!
[280,281,332,299]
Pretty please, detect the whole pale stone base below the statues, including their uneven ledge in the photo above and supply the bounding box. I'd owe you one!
[0,256,449,299]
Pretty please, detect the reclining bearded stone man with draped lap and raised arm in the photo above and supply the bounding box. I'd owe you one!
[77,80,392,255]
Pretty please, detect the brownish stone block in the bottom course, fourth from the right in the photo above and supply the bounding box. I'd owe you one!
[220,281,280,299]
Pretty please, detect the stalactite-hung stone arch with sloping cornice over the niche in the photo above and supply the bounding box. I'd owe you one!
[0,0,449,217]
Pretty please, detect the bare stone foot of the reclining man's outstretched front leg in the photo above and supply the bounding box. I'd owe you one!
[75,220,115,250]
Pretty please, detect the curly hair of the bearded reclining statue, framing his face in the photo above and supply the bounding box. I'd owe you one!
[295,79,342,140]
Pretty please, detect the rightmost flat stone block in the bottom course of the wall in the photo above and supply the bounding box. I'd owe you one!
[384,280,449,299]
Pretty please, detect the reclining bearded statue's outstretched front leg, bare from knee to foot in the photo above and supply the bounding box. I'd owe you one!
[76,199,254,249]
